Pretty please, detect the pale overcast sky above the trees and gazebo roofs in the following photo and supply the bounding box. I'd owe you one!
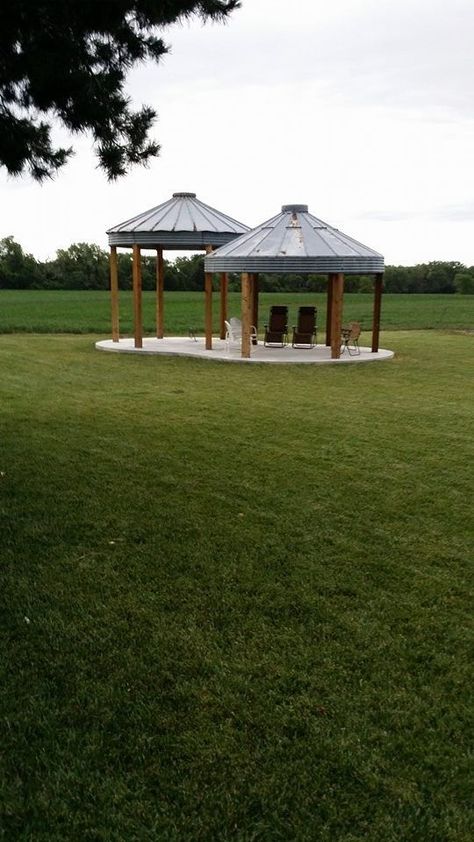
[0,0,474,265]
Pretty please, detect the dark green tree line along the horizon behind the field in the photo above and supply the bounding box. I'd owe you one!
[0,236,474,295]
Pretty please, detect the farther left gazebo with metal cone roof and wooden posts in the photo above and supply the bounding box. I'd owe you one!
[107,193,250,348]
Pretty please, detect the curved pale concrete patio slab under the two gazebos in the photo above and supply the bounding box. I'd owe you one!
[95,336,394,365]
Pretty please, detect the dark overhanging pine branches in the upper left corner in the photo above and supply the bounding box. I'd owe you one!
[0,0,240,181]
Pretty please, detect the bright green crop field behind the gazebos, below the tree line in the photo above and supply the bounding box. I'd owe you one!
[0,290,474,335]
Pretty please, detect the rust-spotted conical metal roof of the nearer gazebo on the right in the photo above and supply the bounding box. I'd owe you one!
[204,205,384,275]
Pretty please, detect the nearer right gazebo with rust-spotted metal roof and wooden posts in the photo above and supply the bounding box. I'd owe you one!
[204,205,384,360]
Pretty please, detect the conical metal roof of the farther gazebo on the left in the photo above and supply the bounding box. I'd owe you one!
[107,193,250,249]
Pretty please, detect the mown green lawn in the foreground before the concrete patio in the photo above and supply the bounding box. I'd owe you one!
[0,330,474,842]
